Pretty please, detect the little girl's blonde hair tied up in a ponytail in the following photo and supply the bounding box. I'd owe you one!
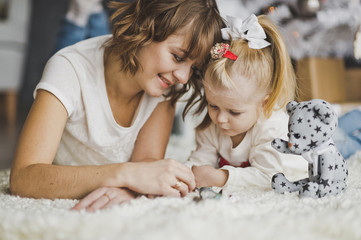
[196,15,296,129]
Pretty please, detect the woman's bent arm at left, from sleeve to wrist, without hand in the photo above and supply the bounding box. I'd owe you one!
[10,90,123,198]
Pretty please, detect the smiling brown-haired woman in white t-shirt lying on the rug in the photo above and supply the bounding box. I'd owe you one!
[10,0,224,210]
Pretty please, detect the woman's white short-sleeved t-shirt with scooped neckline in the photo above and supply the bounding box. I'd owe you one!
[34,35,164,165]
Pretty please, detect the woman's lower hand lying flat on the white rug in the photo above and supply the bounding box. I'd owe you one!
[72,187,137,212]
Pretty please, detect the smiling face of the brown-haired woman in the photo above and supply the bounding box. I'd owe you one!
[134,28,195,97]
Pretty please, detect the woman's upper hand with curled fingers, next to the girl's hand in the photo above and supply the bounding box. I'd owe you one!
[125,159,195,197]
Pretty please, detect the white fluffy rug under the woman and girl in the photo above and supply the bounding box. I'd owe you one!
[0,152,361,240]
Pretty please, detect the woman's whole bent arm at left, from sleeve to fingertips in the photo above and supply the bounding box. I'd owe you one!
[10,93,194,199]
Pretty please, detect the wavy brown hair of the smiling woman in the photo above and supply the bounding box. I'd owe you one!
[105,0,224,114]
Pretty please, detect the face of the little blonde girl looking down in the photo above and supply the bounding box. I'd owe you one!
[204,75,264,137]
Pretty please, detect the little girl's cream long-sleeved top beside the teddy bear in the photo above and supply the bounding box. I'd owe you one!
[186,110,308,191]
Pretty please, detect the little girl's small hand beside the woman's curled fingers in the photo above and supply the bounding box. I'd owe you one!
[192,165,228,187]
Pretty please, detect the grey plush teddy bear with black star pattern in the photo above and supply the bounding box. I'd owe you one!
[272,99,348,198]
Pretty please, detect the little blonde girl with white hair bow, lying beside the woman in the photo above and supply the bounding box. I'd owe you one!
[187,15,307,189]
